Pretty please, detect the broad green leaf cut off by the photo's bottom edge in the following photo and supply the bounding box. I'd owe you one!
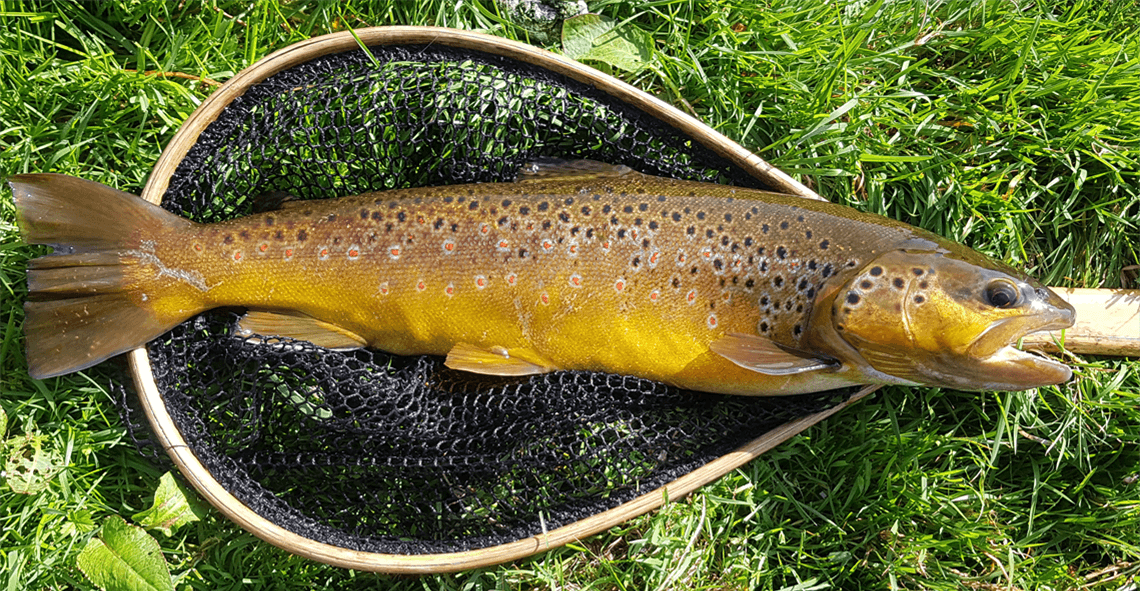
[75,515,174,591]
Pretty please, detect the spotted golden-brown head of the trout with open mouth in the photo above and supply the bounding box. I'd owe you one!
[830,245,1075,390]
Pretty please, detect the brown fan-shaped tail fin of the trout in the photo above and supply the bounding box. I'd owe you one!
[8,175,193,379]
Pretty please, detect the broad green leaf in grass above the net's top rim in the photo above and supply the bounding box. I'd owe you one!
[562,15,653,72]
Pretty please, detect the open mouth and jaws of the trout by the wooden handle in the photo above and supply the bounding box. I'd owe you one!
[968,301,1076,390]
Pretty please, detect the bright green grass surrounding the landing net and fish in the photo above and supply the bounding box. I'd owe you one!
[0,0,1140,590]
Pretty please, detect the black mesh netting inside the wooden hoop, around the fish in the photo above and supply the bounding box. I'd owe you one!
[111,41,846,553]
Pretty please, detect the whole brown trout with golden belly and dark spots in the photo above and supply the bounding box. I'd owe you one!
[9,161,1074,395]
